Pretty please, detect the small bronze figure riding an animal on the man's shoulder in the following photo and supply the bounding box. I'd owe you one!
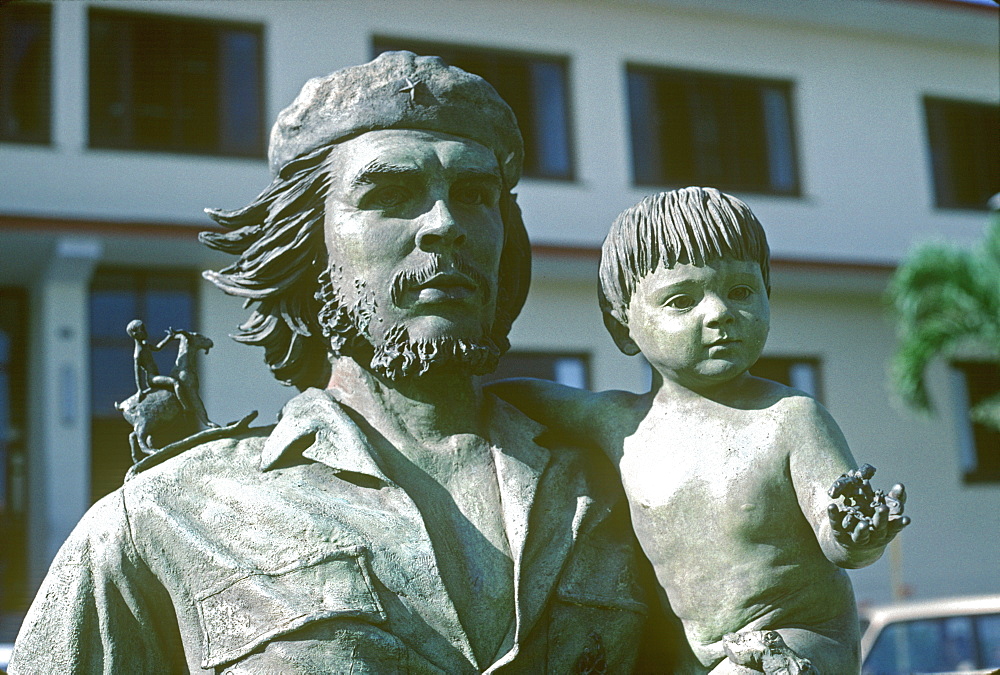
[115,319,218,462]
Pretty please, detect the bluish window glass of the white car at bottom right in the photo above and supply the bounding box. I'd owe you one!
[862,614,1000,675]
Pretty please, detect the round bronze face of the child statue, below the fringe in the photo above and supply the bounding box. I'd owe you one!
[628,258,771,391]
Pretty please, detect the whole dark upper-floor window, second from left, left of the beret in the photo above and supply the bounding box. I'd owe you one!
[90,9,264,157]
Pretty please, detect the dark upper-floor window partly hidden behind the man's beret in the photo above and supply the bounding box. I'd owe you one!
[374,38,573,179]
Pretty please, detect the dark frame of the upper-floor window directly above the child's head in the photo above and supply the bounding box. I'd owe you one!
[624,61,803,198]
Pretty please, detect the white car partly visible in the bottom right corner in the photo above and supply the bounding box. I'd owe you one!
[861,595,1000,675]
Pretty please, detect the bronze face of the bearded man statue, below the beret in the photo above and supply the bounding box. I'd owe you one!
[324,129,503,343]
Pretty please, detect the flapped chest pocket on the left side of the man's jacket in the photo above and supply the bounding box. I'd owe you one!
[196,547,386,669]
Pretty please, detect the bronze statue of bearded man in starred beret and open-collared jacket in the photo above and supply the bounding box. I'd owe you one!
[10,52,667,674]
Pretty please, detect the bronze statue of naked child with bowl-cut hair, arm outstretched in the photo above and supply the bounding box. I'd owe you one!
[494,188,909,675]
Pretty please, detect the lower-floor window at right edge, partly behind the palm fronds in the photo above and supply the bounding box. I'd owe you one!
[951,361,1000,483]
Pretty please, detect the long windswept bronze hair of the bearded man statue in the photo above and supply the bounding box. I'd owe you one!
[198,146,531,390]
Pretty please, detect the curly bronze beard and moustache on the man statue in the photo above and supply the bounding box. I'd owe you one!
[316,260,508,382]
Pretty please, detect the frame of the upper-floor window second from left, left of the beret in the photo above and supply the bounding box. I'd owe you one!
[87,6,268,159]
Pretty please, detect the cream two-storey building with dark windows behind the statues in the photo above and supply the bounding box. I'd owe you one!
[0,0,1000,632]
